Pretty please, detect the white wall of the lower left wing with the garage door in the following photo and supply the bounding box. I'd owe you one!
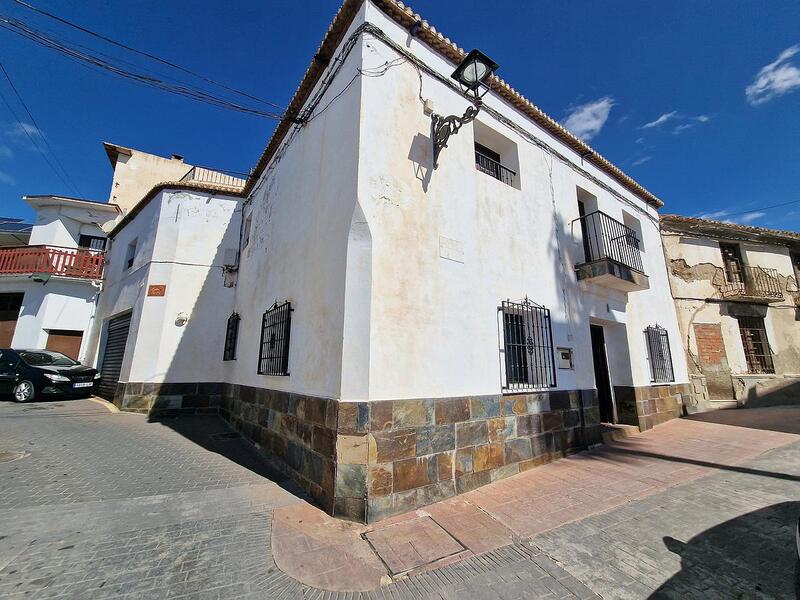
[86,190,240,382]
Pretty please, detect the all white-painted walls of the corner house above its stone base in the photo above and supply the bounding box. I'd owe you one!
[97,1,688,412]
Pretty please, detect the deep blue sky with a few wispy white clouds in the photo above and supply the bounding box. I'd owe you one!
[0,0,800,230]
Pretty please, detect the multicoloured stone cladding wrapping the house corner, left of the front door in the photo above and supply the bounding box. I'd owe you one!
[115,383,602,522]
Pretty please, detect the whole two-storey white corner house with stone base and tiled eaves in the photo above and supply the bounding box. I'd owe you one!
[89,0,694,521]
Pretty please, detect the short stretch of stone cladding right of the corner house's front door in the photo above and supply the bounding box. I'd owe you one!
[614,383,693,431]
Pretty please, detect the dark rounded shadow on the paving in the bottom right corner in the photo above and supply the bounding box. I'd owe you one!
[650,502,800,598]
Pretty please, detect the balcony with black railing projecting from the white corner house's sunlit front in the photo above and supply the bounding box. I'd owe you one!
[573,210,650,292]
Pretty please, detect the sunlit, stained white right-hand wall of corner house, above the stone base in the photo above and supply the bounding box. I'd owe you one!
[358,5,688,399]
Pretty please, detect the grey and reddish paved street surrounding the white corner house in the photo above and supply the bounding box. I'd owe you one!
[0,400,800,600]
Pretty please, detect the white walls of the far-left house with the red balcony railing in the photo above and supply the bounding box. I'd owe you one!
[0,196,119,361]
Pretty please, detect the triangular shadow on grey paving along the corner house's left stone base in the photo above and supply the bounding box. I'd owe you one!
[149,415,310,501]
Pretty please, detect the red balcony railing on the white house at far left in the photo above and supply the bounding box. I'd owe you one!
[0,246,105,279]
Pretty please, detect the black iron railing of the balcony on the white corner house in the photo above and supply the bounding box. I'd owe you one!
[576,210,644,273]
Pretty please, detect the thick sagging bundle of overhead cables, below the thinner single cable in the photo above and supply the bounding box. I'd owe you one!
[0,15,290,120]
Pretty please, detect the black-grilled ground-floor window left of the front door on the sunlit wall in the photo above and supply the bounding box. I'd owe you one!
[500,298,556,392]
